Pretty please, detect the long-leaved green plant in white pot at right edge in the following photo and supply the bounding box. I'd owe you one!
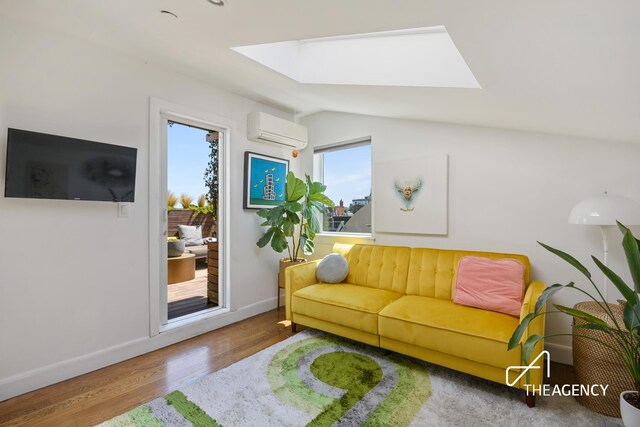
[508,223,640,426]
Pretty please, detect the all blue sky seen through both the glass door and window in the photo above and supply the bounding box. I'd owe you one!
[167,123,371,207]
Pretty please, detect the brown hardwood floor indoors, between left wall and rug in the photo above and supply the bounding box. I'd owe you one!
[0,309,575,427]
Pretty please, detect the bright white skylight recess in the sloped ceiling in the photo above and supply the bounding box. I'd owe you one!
[232,26,480,88]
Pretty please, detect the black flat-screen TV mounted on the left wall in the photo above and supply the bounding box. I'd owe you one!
[4,128,137,202]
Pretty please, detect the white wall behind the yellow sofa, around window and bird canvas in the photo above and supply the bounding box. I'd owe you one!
[301,113,640,363]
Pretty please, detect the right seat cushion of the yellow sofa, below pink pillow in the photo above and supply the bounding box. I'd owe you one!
[378,295,520,368]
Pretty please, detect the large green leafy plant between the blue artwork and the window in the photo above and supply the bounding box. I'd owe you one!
[256,172,334,262]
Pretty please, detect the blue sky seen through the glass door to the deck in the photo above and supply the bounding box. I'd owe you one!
[167,123,210,206]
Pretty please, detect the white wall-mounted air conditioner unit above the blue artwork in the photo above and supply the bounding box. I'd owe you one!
[247,111,309,150]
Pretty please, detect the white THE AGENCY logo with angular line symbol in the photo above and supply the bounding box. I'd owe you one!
[505,350,609,397]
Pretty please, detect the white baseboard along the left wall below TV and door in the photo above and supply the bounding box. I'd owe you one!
[0,297,276,402]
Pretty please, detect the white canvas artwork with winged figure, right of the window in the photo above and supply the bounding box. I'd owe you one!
[373,154,449,235]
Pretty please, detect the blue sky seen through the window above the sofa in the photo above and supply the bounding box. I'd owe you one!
[324,145,371,207]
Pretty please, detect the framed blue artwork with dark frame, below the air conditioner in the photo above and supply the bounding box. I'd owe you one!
[244,151,289,209]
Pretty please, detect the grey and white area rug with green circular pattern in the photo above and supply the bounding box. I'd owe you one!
[101,330,616,427]
